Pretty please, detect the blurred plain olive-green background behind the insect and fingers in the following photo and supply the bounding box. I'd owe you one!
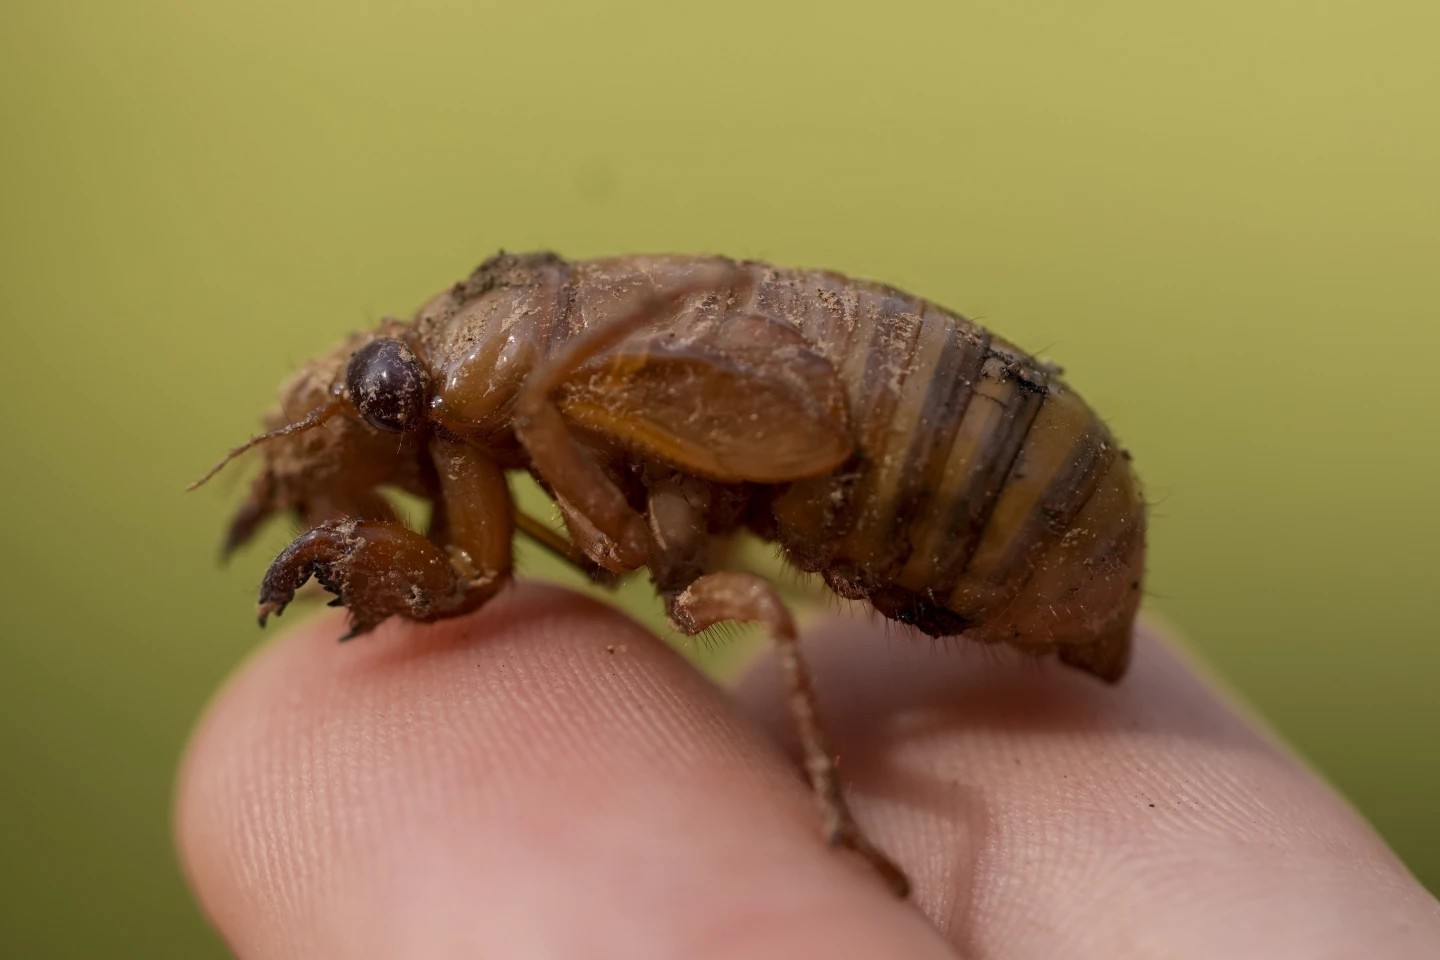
[0,0,1440,957]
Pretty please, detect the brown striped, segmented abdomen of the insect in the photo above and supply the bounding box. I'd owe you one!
[759,273,1145,679]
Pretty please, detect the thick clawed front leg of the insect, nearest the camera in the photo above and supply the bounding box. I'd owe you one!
[259,440,514,639]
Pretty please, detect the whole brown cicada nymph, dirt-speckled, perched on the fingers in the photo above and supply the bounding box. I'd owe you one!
[200,253,1145,895]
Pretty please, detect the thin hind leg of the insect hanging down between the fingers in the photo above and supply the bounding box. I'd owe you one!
[649,479,910,897]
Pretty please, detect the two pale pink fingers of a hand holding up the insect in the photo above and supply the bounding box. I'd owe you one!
[177,586,1440,960]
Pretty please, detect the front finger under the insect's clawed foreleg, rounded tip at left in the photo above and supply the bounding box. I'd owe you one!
[177,587,953,960]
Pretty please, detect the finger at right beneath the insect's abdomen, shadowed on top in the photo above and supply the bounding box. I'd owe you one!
[739,622,1440,960]
